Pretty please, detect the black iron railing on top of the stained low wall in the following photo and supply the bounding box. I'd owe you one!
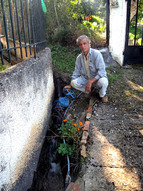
[0,0,46,64]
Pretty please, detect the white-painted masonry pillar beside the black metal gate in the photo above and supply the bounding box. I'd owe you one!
[109,0,127,65]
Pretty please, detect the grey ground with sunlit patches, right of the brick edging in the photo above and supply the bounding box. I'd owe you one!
[59,65,143,191]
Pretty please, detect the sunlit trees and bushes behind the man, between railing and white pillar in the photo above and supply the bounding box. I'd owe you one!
[46,0,106,45]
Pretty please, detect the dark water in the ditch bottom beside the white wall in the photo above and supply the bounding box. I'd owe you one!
[28,128,64,191]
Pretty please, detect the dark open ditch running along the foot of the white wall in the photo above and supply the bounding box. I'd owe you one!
[27,75,82,191]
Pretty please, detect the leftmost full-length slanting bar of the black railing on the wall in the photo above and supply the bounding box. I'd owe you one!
[1,0,11,62]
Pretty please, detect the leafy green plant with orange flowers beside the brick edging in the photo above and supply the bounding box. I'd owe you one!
[57,119,84,156]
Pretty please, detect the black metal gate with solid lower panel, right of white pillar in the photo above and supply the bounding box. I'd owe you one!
[124,0,143,64]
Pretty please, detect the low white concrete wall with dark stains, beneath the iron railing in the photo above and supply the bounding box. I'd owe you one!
[0,48,54,191]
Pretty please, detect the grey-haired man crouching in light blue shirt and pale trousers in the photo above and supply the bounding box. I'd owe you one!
[64,35,108,102]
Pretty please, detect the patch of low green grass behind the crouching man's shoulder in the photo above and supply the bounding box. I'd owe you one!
[48,44,80,73]
